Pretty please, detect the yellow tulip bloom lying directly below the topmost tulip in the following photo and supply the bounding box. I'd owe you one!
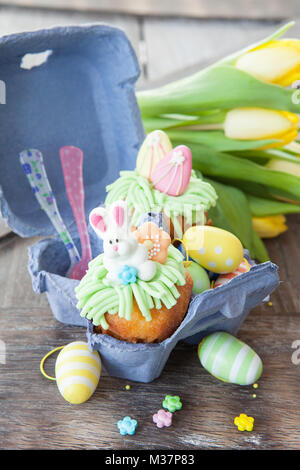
[224,108,299,148]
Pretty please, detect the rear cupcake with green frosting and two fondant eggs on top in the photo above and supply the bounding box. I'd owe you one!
[105,130,217,238]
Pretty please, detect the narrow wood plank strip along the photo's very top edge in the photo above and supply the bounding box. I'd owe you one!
[0,0,300,19]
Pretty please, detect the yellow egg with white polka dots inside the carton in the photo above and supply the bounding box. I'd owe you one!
[183,225,244,274]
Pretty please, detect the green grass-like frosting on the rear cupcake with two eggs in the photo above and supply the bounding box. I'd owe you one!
[105,170,218,238]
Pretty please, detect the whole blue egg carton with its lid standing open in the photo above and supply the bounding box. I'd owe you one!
[0,25,279,382]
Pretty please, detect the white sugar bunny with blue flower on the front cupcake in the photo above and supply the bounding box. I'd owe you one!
[89,201,156,284]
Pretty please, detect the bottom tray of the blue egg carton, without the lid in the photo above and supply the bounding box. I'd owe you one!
[29,234,279,382]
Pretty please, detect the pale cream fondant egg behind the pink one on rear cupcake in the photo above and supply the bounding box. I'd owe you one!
[136,130,172,181]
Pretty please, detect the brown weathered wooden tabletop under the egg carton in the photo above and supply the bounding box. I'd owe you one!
[0,216,300,450]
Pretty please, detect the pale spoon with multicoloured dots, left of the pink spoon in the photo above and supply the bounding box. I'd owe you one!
[19,149,80,275]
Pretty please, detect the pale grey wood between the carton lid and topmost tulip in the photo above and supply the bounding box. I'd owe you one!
[143,18,290,82]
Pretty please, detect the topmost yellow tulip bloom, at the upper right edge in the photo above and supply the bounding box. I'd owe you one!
[235,39,300,86]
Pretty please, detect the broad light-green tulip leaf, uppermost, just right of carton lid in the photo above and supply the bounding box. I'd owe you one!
[137,65,300,116]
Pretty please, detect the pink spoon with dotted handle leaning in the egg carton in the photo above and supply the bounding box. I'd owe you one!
[59,145,92,280]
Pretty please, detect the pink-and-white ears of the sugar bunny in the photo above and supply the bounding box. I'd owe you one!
[89,201,130,238]
